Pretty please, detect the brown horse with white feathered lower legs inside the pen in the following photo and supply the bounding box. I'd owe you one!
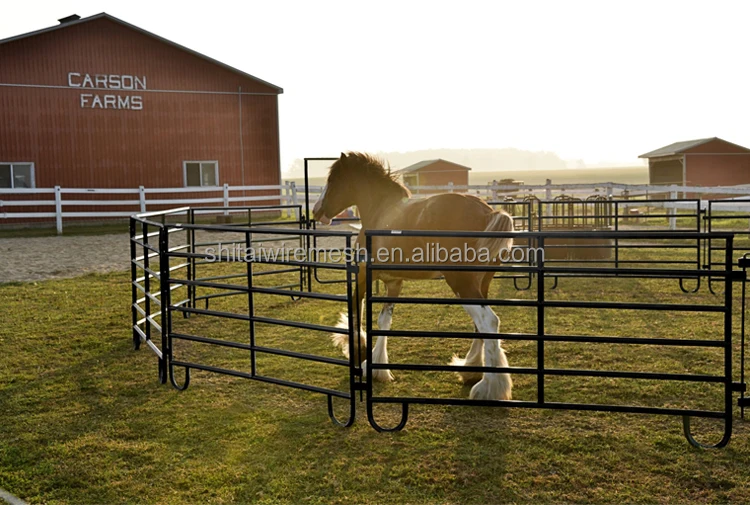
[313,153,513,400]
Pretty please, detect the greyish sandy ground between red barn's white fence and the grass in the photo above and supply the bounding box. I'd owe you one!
[0,225,360,283]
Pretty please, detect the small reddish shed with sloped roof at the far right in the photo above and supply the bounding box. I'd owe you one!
[639,137,750,186]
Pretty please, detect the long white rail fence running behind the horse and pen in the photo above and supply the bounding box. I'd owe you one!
[0,181,750,233]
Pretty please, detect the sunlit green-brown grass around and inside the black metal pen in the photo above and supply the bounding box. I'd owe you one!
[0,242,750,504]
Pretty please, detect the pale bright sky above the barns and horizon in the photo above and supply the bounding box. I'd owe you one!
[0,0,750,170]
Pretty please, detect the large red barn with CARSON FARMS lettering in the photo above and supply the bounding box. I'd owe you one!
[0,13,282,192]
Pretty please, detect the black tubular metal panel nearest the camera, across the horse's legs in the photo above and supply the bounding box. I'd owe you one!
[366,230,744,447]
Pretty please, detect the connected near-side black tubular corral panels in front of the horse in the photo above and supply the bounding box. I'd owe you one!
[130,205,745,448]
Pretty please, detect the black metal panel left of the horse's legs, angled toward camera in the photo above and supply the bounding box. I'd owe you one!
[160,223,363,426]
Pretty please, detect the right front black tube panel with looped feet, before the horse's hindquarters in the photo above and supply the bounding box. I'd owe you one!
[365,230,744,448]
